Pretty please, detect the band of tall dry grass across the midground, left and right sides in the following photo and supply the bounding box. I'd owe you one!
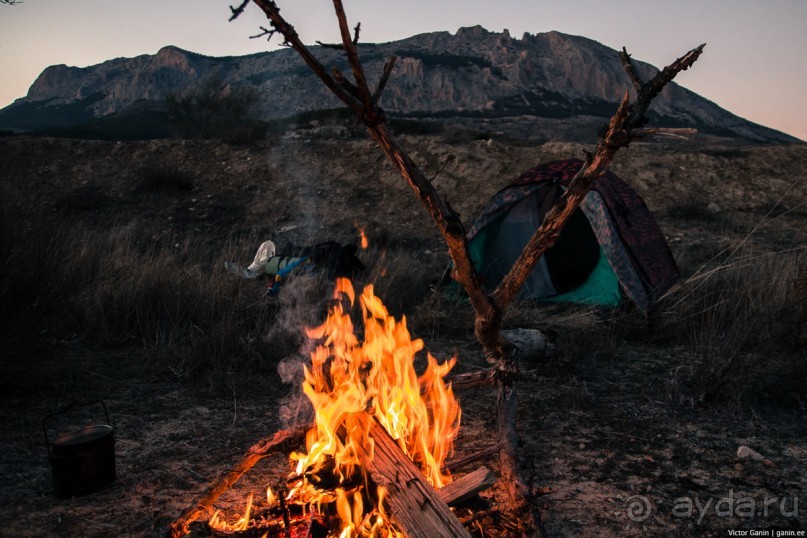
[0,177,807,409]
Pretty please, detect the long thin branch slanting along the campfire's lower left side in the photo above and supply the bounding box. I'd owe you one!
[168,427,307,538]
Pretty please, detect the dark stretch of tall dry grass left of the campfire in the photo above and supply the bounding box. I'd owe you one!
[0,199,279,392]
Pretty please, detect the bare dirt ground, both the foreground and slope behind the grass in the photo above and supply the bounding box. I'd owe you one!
[0,132,807,537]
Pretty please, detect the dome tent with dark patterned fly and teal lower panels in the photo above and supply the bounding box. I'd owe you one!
[468,159,678,312]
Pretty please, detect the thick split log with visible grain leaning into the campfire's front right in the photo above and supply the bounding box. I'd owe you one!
[360,413,470,538]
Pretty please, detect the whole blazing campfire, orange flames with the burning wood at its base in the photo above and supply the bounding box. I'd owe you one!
[208,279,461,537]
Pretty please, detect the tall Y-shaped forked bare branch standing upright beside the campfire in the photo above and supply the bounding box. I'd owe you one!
[230,0,705,536]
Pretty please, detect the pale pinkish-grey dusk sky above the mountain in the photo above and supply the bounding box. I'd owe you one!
[0,0,807,140]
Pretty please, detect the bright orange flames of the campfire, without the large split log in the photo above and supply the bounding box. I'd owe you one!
[209,279,460,538]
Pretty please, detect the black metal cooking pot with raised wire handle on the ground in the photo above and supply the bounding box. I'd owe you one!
[42,400,115,499]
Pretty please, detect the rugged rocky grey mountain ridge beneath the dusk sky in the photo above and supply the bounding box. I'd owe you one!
[0,26,797,142]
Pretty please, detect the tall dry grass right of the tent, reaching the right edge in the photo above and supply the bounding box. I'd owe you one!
[659,248,807,409]
